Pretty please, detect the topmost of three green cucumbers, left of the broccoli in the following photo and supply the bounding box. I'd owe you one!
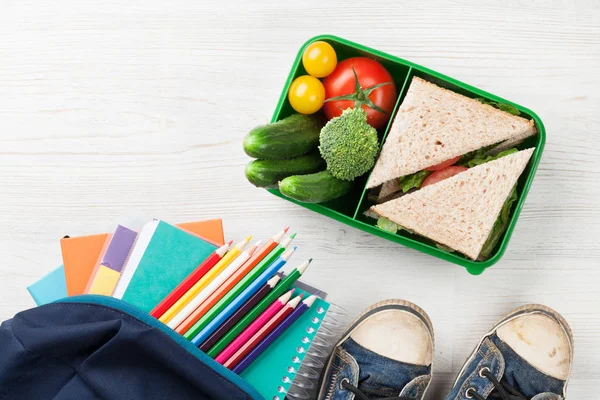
[244,114,324,160]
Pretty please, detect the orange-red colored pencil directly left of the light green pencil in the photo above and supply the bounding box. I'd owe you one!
[174,228,288,335]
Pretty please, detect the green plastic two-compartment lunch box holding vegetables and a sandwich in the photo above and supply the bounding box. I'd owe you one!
[269,35,546,275]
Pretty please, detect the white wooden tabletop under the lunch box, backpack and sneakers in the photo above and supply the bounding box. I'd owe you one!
[0,0,600,399]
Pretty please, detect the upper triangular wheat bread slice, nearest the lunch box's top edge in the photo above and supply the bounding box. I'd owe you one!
[367,77,536,189]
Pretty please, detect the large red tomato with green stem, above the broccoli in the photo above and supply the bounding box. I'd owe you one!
[323,57,396,129]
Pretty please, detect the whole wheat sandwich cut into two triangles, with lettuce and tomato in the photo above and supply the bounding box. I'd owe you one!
[366,77,536,260]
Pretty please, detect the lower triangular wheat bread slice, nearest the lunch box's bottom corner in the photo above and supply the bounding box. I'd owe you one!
[371,148,534,260]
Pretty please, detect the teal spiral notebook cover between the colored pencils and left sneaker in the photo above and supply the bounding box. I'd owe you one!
[241,289,329,400]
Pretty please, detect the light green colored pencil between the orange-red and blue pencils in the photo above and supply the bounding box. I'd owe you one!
[183,233,296,340]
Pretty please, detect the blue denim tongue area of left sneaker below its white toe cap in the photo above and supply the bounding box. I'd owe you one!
[342,338,431,399]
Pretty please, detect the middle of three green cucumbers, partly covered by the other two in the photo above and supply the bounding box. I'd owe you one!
[246,152,325,188]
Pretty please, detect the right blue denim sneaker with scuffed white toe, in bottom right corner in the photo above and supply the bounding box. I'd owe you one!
[446,304,573,400]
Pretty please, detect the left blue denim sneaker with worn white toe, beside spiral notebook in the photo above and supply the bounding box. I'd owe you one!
[317,300,433,400]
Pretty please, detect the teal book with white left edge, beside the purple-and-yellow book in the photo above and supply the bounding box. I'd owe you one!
[113,220,217,312]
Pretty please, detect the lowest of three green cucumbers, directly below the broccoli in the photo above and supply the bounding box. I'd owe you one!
[279,171,352,203]
